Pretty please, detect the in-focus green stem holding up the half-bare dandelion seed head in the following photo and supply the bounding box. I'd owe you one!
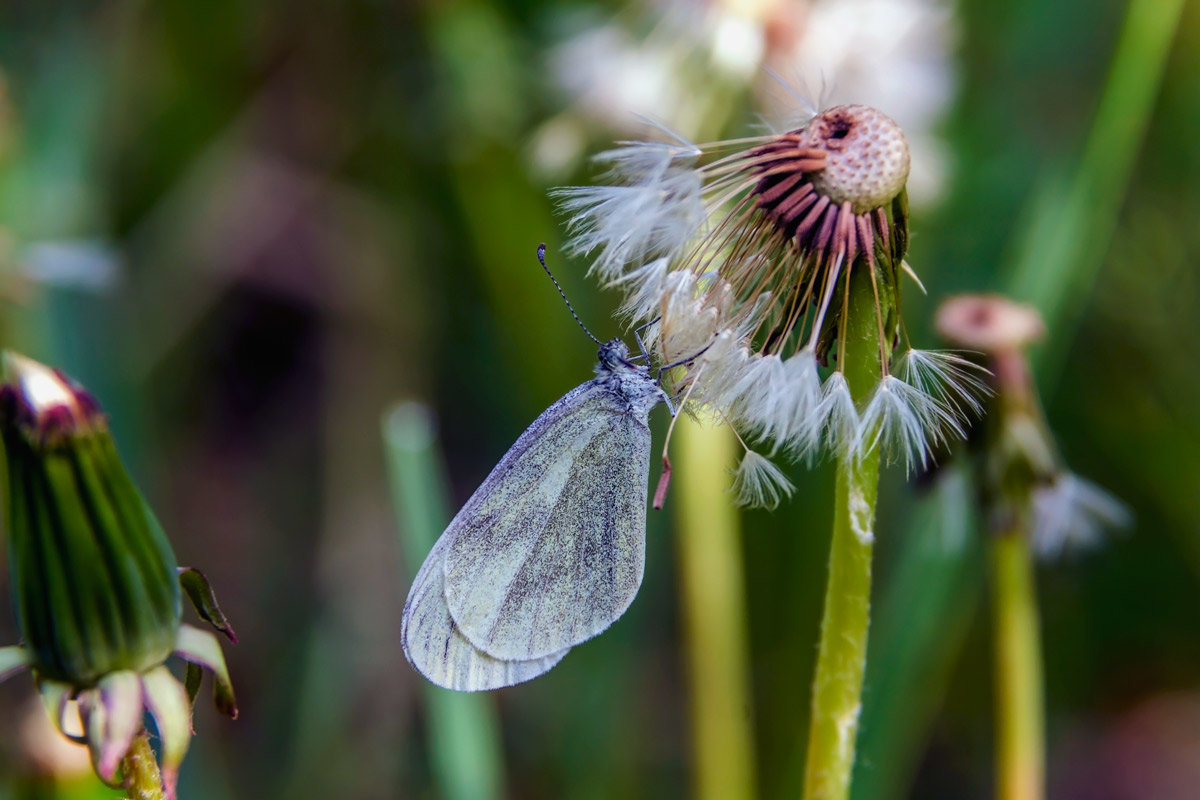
[804,270,880,800]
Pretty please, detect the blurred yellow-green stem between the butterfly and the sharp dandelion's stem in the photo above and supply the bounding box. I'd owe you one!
[676,417,755,800]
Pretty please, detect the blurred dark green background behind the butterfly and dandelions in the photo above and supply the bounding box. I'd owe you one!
[0,0,1200,800]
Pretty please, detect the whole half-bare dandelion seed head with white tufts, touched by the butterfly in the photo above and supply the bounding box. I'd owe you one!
[558,100,985,469]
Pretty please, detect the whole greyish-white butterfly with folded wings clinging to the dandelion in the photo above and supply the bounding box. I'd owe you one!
[401,339,668,692]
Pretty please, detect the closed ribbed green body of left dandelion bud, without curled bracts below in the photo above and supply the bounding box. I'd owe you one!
[0,354,181,686]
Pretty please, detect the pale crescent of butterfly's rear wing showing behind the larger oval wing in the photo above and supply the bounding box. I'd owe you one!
[401,534,566,692]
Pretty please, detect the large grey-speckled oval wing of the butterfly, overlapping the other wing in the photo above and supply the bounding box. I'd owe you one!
[443,378,658,661]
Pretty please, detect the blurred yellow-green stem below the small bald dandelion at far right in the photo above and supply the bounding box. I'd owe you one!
[991,530,1045,800]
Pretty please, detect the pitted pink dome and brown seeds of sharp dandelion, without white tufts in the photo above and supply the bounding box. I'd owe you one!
[676,106,908,379]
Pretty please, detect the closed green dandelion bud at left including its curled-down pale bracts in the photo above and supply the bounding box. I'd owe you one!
[0,353,236,796]
